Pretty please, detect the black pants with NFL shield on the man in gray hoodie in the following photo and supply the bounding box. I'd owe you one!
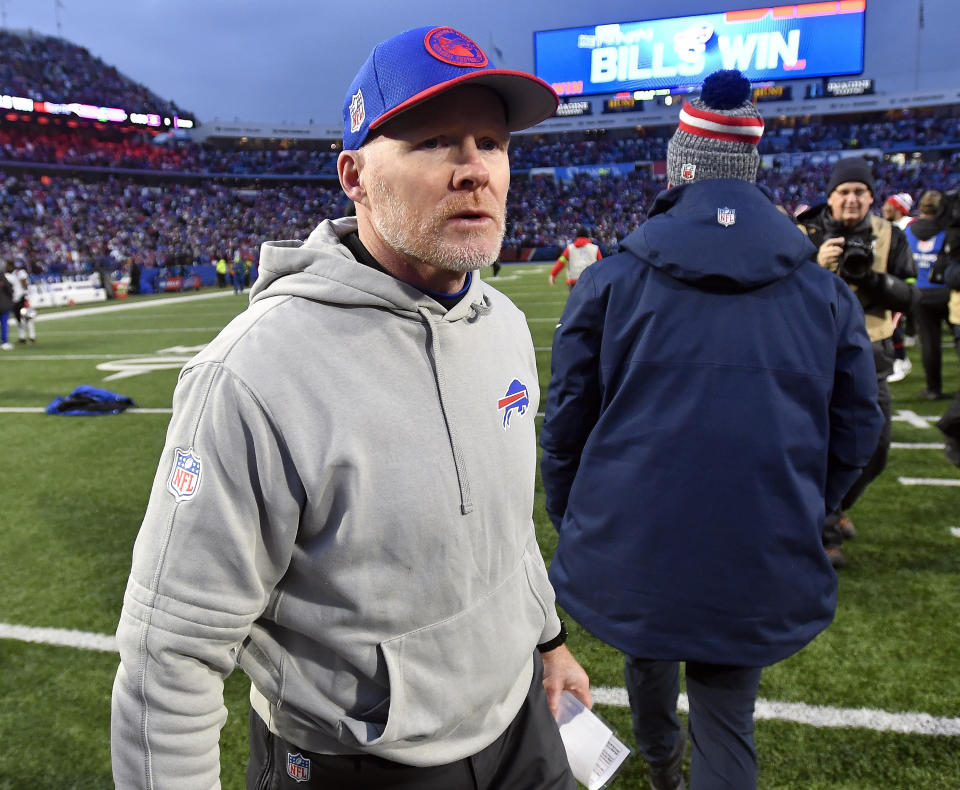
[247,653,576,790]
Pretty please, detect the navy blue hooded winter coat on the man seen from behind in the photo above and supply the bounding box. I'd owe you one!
[541,179,883,666]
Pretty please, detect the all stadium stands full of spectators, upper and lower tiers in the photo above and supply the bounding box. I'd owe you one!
[0,31,960,277]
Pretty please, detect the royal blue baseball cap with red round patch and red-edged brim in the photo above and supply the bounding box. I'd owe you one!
[343,27,559,150]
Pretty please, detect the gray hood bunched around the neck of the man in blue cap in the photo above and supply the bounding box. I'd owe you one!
[250,217,490,321]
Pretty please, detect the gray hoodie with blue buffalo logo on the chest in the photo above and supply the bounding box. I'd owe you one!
[112,219,560,790]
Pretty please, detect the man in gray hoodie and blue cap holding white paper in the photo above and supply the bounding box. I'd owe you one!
[112,27,590,790]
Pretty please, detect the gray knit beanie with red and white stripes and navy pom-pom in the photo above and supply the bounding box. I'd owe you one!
[667,70,763,186]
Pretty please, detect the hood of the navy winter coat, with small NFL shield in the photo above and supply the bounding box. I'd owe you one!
[622,178,816,293]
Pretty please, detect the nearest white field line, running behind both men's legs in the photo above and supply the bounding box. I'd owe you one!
[0,623,960,736]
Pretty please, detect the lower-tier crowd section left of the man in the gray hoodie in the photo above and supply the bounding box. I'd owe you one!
[0,172,343,276]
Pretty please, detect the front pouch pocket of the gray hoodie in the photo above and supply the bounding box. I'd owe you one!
[342,554,546,747]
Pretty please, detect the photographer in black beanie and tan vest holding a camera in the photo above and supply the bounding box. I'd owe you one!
[797,157,920,567]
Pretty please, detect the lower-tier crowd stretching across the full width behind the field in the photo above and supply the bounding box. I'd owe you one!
[0,148,957,275]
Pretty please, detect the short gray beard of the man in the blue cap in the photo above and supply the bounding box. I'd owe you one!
[370,179,506,272]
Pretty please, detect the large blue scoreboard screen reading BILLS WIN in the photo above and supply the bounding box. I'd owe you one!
[533,0,866,96]
